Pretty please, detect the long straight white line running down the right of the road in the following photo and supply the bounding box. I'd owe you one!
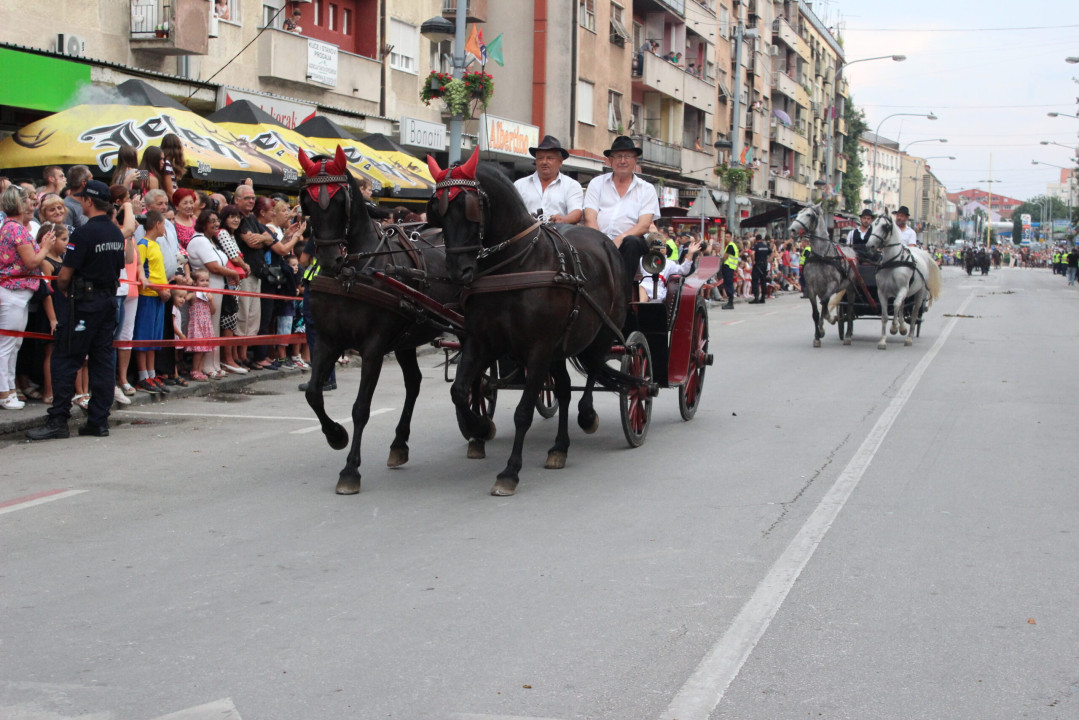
[659,293,974,720]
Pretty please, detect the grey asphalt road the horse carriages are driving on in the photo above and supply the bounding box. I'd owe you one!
[0,269,1079,720]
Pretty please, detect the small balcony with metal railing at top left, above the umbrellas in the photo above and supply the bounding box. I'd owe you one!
[131,0,213,55]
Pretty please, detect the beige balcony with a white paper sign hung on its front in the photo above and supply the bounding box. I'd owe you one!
[256,29,382,104]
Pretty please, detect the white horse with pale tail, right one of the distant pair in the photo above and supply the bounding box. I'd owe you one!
[865,215,941,350]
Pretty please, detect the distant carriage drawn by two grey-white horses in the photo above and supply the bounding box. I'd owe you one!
[790,204,941,350]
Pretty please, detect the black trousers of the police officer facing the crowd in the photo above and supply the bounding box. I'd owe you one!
[49,295,117,427]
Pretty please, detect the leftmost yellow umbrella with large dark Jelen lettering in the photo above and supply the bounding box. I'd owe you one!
[0,81,297,187]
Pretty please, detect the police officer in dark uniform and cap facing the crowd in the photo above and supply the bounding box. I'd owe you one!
[26,180,124,440]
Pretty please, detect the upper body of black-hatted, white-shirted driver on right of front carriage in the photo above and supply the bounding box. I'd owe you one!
[585,135,659,247]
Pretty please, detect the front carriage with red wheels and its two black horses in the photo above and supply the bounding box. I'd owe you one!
[300,149,718,495]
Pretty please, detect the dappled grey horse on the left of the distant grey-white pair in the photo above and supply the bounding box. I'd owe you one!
[790,203,858,348]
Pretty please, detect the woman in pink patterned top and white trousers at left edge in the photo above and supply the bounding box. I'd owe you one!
[0,186,56,410]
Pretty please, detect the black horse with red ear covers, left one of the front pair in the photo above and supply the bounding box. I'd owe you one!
[299,147,461,494]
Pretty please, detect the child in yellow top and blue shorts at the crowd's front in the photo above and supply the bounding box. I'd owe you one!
[134,210,172,395]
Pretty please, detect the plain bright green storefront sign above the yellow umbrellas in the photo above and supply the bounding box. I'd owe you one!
[0,47,90,112]
